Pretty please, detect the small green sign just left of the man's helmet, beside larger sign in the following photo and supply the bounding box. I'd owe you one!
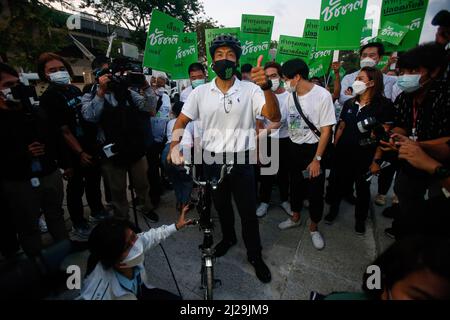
[172,32,198,80]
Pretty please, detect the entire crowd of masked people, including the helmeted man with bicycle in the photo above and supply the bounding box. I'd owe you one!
[0,11,450,299]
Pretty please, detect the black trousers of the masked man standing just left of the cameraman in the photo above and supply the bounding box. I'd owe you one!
[66,161,105,227]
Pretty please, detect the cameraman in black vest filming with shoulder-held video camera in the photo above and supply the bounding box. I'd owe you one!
[82,58,159,222]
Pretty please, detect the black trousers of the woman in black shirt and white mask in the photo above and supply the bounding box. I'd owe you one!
[330,145,375,222]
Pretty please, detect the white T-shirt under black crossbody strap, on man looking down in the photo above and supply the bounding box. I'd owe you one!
[287,85,336,144]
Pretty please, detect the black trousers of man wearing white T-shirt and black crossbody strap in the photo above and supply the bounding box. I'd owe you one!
[289,141,325,223]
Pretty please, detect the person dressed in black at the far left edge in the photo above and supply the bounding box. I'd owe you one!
[0,63,68,261]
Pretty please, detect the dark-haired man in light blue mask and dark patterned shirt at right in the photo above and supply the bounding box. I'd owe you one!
[382,43,450,238]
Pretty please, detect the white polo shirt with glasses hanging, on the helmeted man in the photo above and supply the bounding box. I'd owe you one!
[182,78,266,153]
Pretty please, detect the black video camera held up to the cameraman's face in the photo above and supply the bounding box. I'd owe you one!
[95,58,145,93]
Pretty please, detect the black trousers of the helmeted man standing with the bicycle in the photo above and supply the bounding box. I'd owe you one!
[204,164,262,259]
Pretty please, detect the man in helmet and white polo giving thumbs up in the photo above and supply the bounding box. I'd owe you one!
[169,35,281,283]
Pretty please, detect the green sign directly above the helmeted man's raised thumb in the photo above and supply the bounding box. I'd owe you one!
[239,14,275,66]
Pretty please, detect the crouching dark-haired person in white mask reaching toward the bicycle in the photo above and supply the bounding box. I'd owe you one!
[81,207,192,300]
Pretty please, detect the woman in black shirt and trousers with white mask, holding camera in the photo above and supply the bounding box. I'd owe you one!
[325,67,394,235]
